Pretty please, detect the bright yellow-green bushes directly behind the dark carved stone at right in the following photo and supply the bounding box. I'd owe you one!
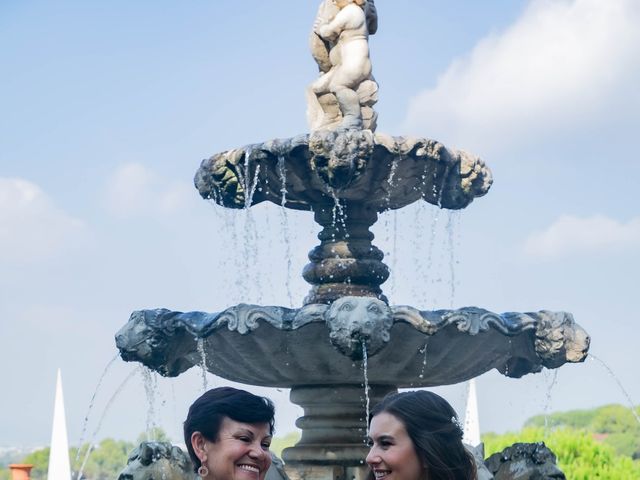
[483,427,640,480]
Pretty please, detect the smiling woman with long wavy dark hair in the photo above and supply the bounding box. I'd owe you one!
[367,391,477,480]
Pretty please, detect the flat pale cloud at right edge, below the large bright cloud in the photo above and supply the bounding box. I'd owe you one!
[524,215,640,258]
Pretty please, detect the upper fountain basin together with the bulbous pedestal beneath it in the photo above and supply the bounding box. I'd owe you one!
[195,130,492,304]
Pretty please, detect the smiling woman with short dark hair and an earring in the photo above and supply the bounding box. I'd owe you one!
[184,387,275,480]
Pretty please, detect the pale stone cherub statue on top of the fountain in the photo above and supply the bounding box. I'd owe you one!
[307,0,378,131]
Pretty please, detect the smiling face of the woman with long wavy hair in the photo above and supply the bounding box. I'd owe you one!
[367,412,428,480]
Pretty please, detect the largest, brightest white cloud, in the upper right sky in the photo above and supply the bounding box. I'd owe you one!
[405,0,640,151]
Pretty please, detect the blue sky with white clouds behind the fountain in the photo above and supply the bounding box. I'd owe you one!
[0,0,640,445]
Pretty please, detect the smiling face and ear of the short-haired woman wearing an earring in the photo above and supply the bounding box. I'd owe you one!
[191,417,271,480]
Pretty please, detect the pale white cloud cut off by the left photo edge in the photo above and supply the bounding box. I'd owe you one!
[0,178,84,263]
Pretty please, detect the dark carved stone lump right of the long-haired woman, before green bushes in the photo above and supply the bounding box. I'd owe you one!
[485,442,566,480]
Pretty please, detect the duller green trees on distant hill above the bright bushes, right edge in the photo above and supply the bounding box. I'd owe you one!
[525,405,640,458]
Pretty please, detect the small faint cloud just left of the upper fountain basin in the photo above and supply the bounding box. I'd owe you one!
[105,163,195,217]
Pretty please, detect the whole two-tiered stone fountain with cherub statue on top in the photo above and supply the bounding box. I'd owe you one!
[116,0,589,479]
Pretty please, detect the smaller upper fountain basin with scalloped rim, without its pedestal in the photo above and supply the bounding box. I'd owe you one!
[195,130,492,212]
